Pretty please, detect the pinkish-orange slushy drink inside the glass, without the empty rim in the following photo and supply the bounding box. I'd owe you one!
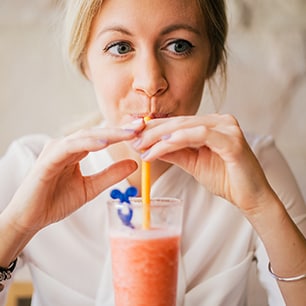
[111,229,180,306]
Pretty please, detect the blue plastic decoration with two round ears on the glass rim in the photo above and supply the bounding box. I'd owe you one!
[110,186,138,228]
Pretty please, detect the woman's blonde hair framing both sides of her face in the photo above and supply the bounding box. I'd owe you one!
[64,0,228,77]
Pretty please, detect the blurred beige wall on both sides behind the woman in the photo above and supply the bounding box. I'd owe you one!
[0,0,306,302]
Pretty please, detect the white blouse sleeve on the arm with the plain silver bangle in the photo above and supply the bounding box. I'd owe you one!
[253,137,306,305]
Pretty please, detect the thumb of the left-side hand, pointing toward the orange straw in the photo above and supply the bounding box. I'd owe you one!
[84,160,138,200]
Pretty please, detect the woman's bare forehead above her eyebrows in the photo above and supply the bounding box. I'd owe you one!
[92,0,206,38]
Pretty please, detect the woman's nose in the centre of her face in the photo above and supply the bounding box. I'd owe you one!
[133,54,169,98]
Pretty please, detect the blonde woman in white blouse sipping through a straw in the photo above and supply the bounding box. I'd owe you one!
[0,0,306,306]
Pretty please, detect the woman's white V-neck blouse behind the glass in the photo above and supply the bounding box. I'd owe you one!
[0,135,306,306]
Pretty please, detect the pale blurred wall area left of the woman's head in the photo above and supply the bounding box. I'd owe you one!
[0,0,96,154]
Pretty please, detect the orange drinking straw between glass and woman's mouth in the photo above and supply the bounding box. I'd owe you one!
[141,117,151,230]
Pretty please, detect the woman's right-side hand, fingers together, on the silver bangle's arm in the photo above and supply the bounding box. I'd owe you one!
[134,114,271,211]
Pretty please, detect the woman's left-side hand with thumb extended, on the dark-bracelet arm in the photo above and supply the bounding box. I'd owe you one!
[8,122,144,233]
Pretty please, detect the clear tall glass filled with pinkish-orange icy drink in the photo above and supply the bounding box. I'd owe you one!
[108,198,183,306]
